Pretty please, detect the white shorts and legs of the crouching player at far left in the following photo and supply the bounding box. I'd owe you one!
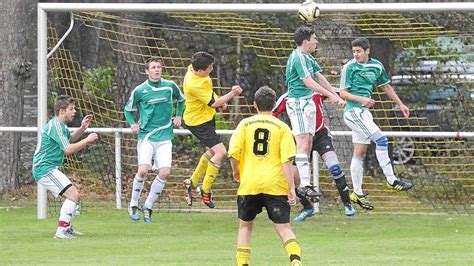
[38,169,79,239]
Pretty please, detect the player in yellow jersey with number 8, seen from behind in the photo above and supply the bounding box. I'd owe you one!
[229,86,301,265]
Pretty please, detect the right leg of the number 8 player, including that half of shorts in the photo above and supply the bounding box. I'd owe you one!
[263,194,301,265]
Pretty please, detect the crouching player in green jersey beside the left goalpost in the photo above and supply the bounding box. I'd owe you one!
[33,95,98,239]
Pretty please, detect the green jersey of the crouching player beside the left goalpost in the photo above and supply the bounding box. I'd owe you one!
[33,117,71,181]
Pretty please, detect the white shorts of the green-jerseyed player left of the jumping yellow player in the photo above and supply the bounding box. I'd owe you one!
[137,140,172,170]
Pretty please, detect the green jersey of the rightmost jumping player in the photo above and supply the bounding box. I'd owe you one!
[340,58,390,111]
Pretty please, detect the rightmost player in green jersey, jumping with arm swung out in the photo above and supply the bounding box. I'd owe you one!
[340,38,412,210]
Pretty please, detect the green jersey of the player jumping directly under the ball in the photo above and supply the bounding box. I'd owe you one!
[285,48,321,98]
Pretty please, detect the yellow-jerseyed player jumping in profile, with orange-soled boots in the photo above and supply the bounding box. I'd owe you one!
[183,52,242,208]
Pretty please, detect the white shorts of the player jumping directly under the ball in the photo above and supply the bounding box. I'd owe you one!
[286,95,316,136]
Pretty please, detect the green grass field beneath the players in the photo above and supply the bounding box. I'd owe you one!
[0,207,474,265]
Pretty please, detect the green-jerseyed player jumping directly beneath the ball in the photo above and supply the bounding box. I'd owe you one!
[286,26,345,201]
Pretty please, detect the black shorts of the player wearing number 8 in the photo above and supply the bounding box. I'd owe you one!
[237,194,290,224]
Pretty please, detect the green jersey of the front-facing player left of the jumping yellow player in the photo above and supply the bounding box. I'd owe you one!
[124,78,184,142]
